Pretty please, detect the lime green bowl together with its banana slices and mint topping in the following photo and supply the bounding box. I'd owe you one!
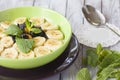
[0,7,72,69]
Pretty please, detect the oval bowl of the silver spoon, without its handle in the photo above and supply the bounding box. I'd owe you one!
[82,5,106,26]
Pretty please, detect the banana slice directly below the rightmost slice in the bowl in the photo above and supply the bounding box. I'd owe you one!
[44,39,62,51]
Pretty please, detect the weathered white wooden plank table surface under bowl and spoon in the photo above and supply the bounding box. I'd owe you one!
[0,0,120,80]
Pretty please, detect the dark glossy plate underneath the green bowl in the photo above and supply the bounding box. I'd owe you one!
[0,34,79,80]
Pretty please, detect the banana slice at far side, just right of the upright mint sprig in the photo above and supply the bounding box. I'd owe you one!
[30,17,45,27]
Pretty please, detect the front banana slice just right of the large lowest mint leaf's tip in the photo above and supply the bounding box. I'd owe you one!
[34,46,51,57]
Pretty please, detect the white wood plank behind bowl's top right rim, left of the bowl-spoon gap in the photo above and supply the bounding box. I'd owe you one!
[35,0,66,16]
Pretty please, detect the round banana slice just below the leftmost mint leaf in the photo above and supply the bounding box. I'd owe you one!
[1,36,14,47]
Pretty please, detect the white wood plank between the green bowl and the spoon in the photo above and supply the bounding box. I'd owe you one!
[65,0,84,33]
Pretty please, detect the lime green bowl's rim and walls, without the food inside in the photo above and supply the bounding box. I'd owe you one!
[0,7,72,69]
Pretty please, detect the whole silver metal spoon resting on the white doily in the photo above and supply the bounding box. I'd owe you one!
[82,5,120,37]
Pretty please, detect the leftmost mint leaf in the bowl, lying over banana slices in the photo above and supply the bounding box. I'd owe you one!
[4,24,23,36]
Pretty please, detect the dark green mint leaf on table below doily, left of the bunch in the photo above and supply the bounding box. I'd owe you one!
[87,48,98,67]
